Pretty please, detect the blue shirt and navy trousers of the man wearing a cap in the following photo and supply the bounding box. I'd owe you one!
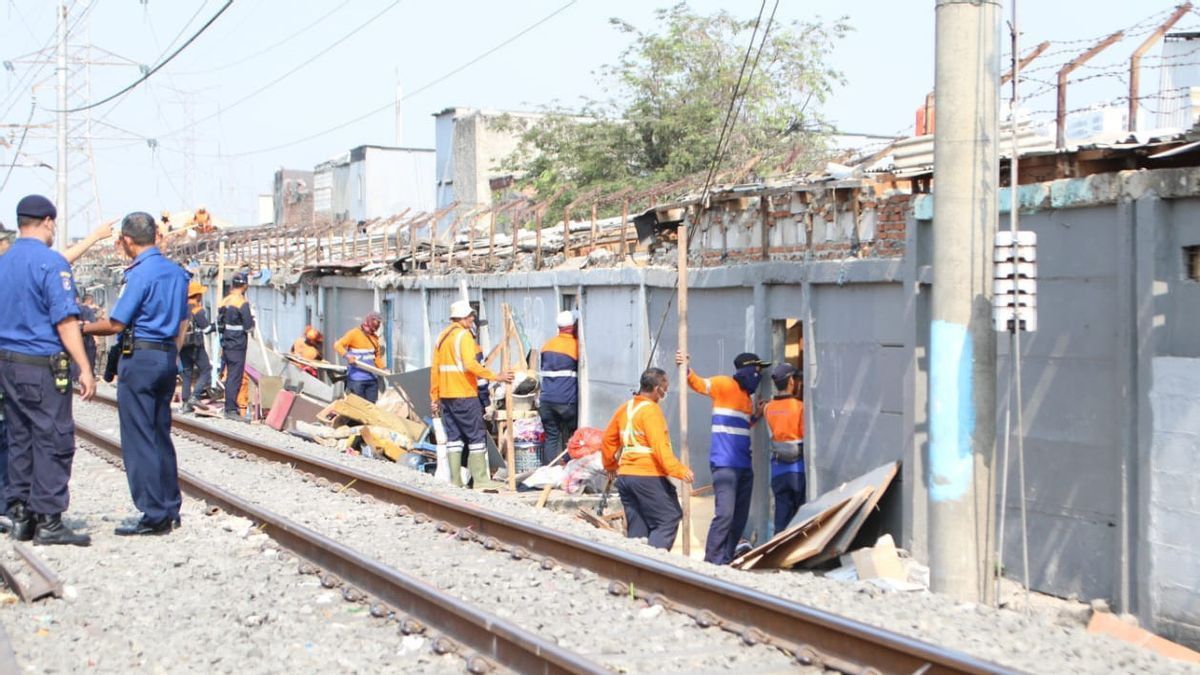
[0,237,79,515]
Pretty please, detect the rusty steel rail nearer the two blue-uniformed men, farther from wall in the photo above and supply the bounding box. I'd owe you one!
[76,422,608,674]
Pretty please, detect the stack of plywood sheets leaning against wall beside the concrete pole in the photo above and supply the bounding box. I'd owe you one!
[731,462,900,569]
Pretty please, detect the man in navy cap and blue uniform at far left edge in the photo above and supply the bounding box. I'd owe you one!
[0,195,96,546]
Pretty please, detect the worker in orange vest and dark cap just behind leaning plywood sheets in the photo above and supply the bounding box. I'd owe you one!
[762,363,805,534]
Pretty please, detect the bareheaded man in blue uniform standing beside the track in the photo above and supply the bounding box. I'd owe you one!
[84,211,188,536]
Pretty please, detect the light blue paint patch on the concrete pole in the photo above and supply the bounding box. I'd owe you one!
[929,321,976,501]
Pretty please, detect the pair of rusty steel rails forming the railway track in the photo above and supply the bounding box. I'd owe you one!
[87,396,1007,674]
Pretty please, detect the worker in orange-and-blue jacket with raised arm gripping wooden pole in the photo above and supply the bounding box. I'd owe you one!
[676,352,770,565]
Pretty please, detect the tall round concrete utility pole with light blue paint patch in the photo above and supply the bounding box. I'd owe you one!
[929,0,1000,602]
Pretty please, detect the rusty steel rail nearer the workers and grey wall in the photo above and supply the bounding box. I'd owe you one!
[88,395,1013,675]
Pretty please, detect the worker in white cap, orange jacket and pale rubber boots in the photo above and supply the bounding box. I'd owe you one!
[430,300,514,489]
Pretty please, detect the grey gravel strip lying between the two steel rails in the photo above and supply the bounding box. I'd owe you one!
[76,406,803,673]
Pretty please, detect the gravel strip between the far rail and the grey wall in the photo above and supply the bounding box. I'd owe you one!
[77,393,1200,673]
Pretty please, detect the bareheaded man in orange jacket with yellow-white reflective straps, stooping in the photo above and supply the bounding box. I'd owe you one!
[600,368,695,550]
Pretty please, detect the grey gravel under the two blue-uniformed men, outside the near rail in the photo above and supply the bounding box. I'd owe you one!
[0,450,463,673]
